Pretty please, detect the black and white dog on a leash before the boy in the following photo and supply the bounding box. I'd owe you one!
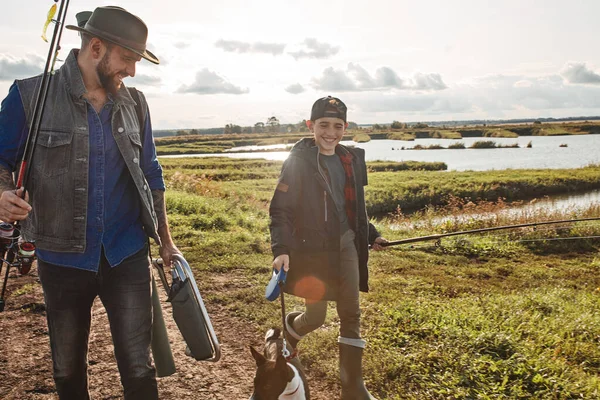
[250,328,310,400]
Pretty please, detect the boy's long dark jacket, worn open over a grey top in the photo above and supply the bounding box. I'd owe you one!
[269,138,379,300]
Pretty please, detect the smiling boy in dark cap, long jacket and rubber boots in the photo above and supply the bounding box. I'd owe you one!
[269,97,386,400]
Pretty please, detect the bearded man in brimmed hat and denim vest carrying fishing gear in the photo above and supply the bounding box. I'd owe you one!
[0,7,179,400]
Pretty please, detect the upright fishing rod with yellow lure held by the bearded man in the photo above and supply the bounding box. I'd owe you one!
[0,0,70,312]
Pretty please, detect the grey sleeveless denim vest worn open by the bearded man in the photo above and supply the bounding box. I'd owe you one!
[17,50,160,253]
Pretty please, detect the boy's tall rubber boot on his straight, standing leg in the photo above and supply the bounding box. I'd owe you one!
[338,337,376,400]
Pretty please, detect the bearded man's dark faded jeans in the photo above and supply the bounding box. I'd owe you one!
[38,247,158,400]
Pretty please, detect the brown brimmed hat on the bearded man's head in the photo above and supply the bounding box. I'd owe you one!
[67,6,159,64]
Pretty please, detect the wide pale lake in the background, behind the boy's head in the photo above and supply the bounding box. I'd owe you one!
[163,135,600,171]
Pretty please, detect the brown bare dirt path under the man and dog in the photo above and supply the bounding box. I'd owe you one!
[0,268,339,400]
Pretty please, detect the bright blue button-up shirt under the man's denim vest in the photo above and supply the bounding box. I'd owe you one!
[0,84,165,271]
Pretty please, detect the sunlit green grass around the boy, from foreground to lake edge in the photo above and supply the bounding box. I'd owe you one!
[156,158,600,400]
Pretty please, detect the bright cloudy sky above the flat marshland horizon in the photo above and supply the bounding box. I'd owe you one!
[0,0,600,129]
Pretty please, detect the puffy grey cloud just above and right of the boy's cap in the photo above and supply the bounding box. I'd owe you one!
[312,63,447,92]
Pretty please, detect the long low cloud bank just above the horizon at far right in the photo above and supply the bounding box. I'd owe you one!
[353,74,600,120]
